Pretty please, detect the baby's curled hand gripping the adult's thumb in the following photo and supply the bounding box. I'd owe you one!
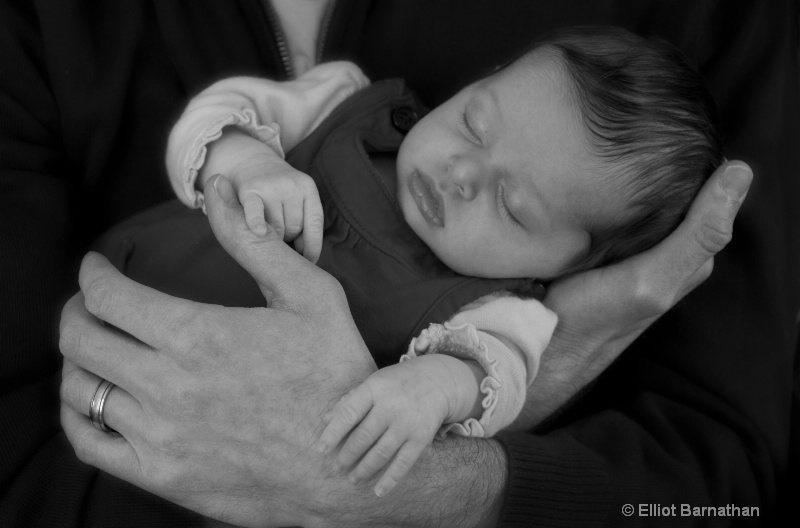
[231,158,323,263]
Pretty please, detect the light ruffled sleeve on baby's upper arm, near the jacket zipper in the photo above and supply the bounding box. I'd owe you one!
[166,62,369,207]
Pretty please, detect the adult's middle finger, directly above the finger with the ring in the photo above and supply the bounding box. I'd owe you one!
[59,292,163,392]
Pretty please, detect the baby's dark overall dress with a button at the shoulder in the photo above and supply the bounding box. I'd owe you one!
[100,80,530,366]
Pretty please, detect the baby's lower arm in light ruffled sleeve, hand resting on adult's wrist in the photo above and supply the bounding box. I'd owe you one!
[319,292,558,495]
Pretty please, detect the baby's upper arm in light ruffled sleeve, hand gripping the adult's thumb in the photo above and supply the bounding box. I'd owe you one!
[166,62,369,258]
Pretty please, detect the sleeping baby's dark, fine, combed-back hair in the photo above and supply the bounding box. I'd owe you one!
[523,26,724,272]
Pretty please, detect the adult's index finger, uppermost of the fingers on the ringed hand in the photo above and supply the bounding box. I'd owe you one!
[75,252,202,352]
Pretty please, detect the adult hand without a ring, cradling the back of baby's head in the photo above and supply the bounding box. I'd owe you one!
[514,161,753,429]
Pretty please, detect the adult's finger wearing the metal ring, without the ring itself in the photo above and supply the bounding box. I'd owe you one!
[61,360,142,438]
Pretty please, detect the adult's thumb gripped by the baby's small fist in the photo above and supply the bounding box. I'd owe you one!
[205,174,322,308]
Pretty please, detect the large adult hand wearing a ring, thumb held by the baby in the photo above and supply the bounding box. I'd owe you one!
[60,178,375,526]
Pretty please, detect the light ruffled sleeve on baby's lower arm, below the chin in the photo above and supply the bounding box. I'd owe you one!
[400,292,558,437]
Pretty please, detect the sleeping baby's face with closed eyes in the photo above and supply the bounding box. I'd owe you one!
[397,51,616,278]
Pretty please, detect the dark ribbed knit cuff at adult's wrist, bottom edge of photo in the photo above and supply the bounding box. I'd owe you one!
[495,432,613,528]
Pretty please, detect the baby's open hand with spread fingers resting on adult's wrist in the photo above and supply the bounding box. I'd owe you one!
[318,354,459,497]
